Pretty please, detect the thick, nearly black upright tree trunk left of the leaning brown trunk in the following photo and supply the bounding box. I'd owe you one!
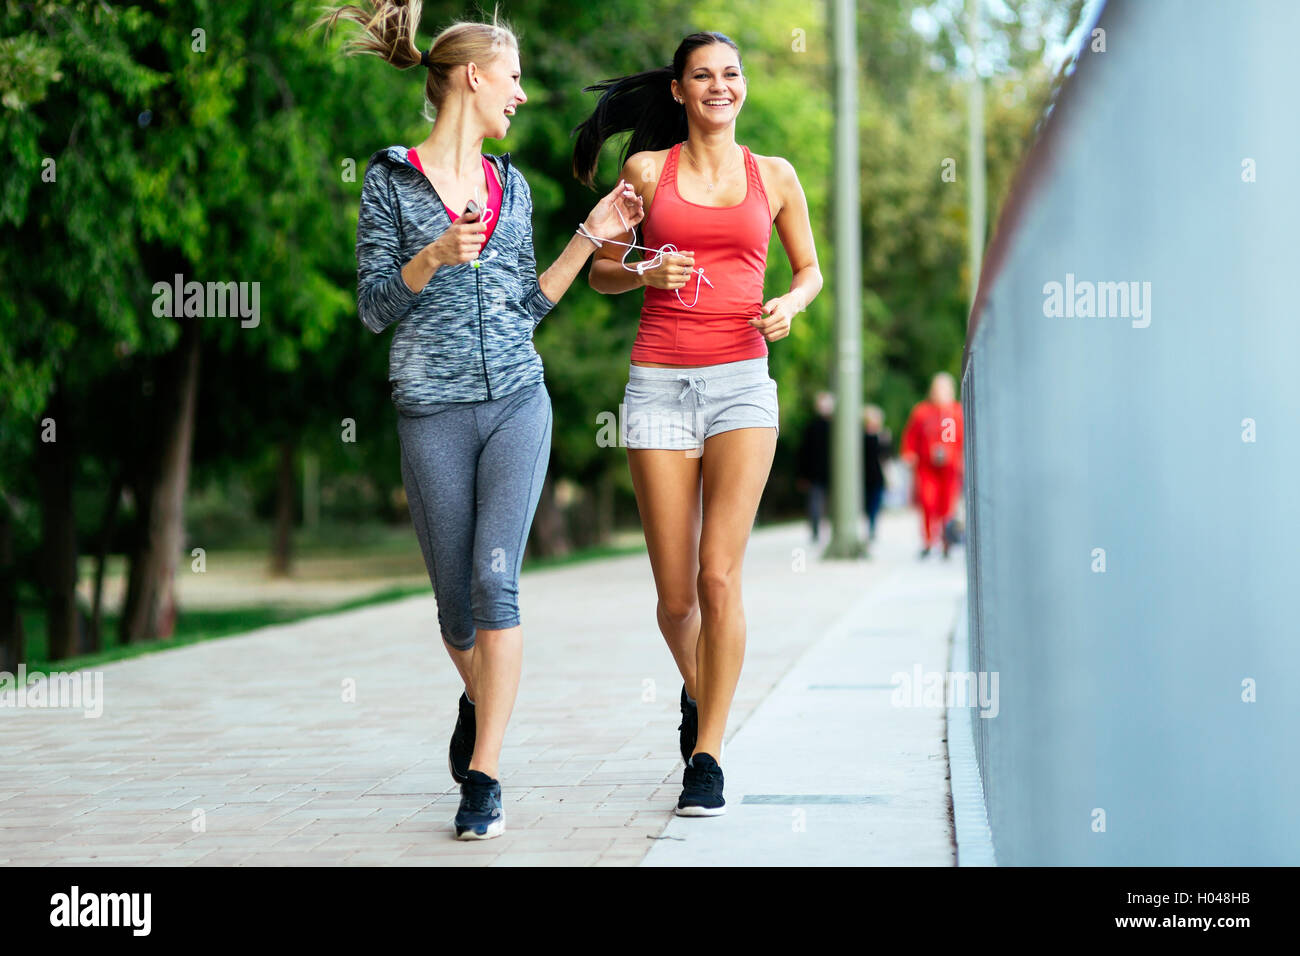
[36,386,85,661]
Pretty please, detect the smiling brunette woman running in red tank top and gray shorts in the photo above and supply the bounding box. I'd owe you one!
[573,33,822,816]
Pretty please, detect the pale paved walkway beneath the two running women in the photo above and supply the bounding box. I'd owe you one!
[0,514,965,866]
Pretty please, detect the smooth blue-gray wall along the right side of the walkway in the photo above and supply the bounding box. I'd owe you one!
[962,0,1300,865]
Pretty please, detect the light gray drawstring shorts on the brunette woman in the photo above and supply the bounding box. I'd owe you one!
[619,355,780,451]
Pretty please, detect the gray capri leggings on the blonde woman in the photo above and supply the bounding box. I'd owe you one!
[398,382,551,650]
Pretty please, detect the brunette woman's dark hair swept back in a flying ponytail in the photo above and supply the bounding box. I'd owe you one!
[573,31,740,186]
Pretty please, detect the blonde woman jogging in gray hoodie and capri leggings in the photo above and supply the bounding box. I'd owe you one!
[320,0,642,839]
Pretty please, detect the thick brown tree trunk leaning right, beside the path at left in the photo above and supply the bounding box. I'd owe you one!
[122,319,199,644]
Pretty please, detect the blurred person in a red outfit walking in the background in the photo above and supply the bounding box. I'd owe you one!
[902,372,963,558]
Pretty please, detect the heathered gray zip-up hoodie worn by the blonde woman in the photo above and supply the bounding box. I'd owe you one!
[356,146,555,410]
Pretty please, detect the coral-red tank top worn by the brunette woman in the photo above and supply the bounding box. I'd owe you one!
[632,143,772,365]
